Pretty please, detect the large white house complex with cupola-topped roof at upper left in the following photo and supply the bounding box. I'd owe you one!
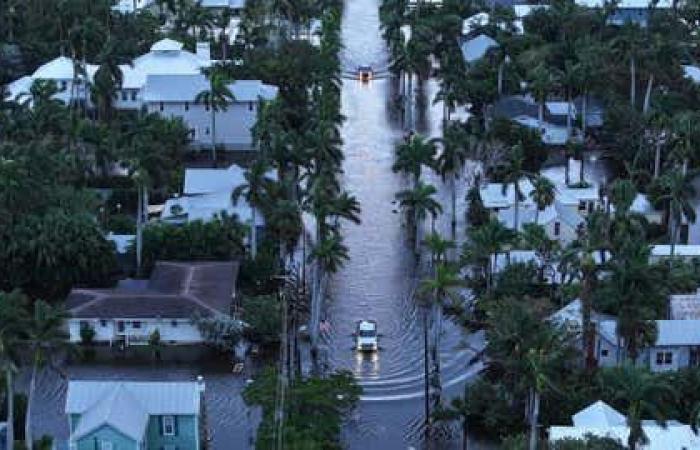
[8,39,278,150]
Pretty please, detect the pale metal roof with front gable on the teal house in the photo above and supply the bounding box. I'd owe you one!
[65,381,200,441]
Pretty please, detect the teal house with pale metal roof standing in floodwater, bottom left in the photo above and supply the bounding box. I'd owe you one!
[66,381,204,450]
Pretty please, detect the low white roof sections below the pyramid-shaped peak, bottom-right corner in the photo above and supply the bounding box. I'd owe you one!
[549,424,700,450]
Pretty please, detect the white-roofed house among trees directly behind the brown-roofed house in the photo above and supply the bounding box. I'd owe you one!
[160,164,277,236]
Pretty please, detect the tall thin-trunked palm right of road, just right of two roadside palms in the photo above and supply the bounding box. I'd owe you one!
[436,124,469,239]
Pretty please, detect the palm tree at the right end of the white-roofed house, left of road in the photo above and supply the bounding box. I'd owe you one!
[231,158,272,259]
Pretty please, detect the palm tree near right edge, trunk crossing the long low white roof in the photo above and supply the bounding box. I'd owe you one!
[660,171,696,257]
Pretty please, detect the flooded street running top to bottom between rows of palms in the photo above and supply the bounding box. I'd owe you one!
[327,0,484,450]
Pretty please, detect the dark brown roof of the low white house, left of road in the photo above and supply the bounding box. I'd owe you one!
[66,261,238,319]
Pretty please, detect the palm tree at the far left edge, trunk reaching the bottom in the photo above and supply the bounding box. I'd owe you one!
[0,291,27,448]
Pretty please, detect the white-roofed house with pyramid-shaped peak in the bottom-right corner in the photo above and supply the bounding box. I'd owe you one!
[549,400,700,450]
